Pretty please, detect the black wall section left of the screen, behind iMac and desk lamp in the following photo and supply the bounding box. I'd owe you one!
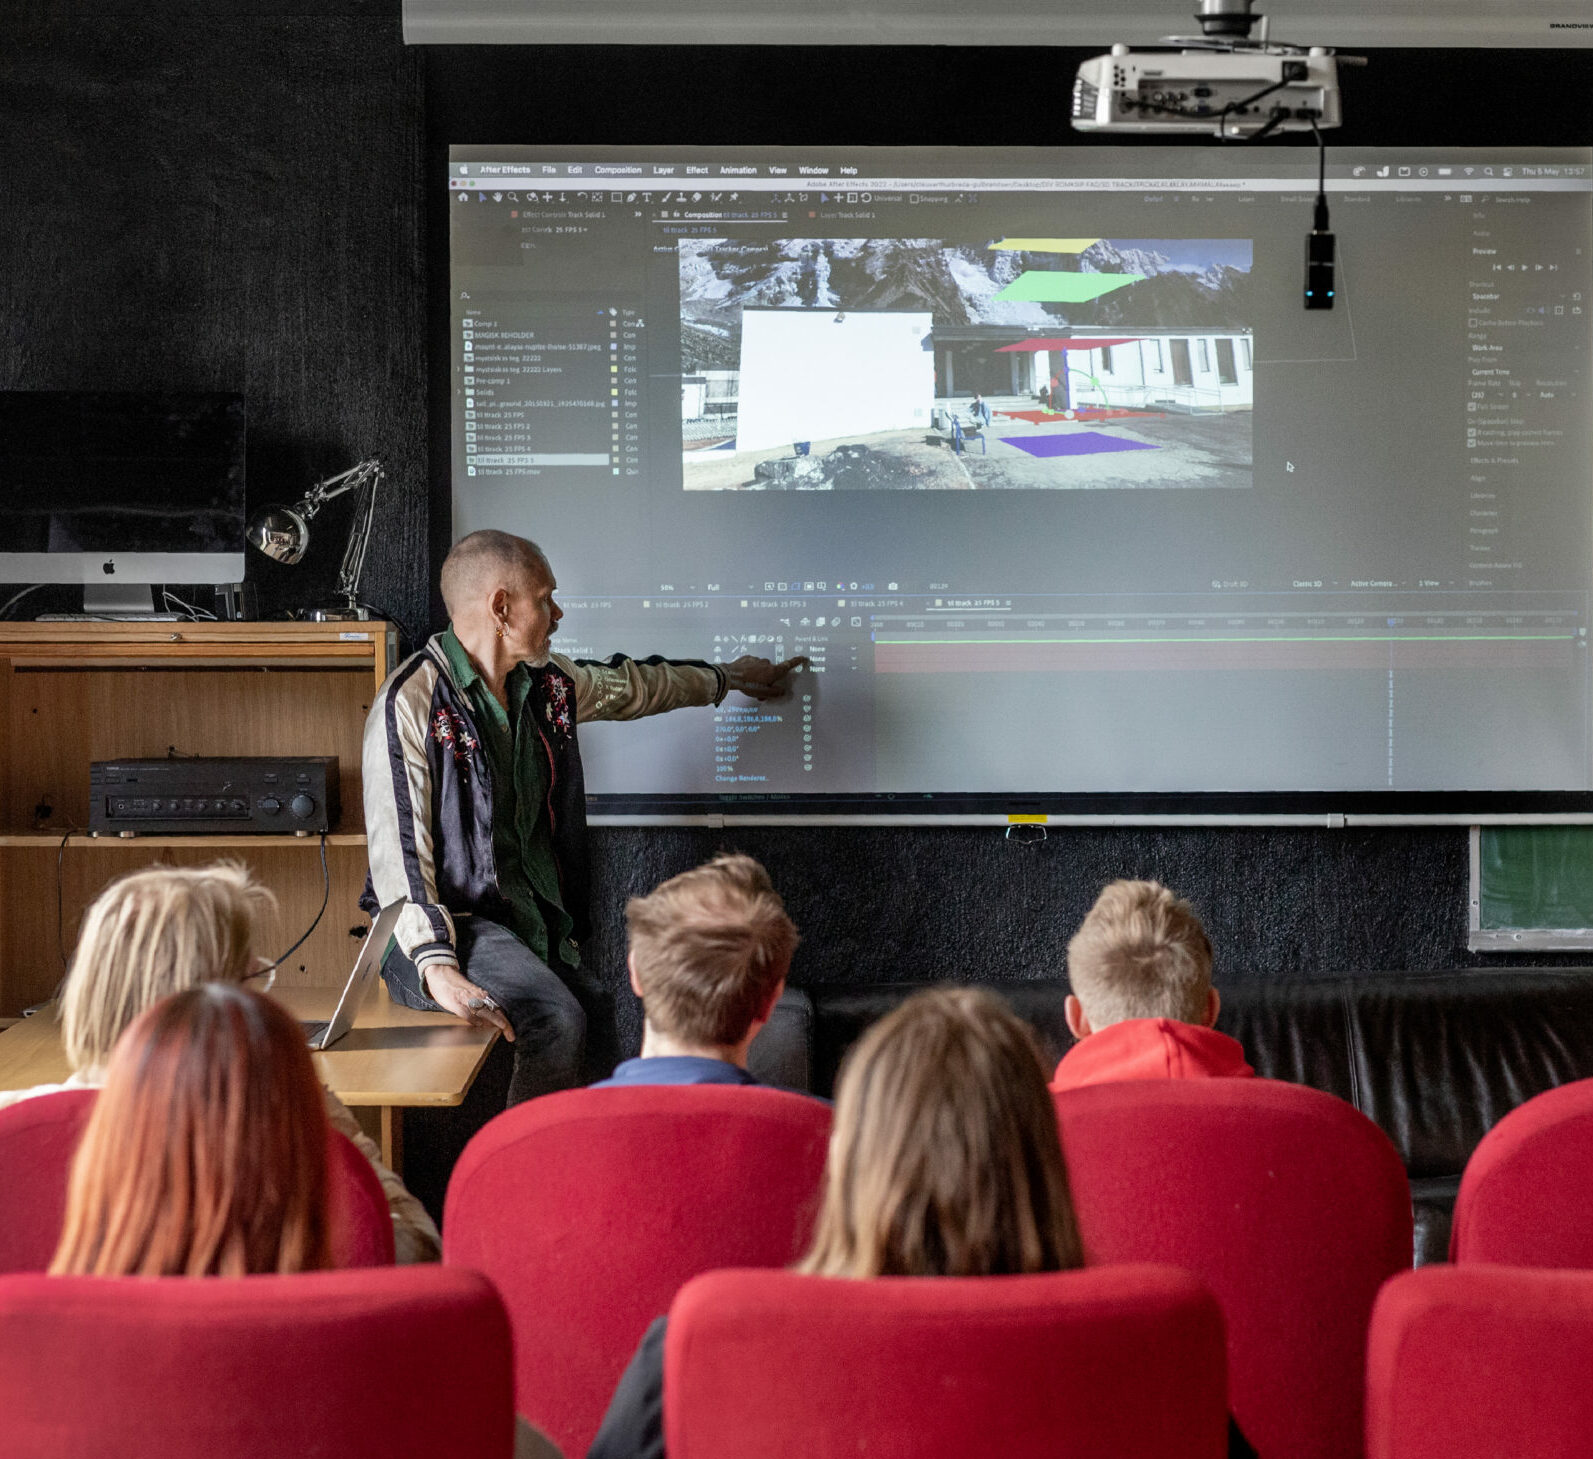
[0,0,429,623]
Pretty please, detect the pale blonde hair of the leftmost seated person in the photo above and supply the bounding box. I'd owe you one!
[61,862,276,1070]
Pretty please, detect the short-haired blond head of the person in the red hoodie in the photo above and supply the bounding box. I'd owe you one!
[1067,881,1215,1029]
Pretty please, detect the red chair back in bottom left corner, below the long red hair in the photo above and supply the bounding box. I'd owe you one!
[0,1266,515,1459]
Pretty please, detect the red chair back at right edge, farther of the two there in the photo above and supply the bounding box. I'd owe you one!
[1450,1080,1593,1268]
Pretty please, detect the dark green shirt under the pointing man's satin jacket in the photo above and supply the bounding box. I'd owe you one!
[441,628,581,968]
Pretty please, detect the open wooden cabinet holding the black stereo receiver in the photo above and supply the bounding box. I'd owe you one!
[0,623,397,1016]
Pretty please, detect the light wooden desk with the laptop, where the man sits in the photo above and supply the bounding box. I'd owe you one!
[0,983,497,1171]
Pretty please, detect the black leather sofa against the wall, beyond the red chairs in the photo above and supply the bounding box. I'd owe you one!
[752,968,1593,1265]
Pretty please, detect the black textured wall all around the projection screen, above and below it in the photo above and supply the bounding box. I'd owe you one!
[0,11,1593,1063]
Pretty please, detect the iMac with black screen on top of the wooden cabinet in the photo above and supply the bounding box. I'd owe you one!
[0,390,245,616]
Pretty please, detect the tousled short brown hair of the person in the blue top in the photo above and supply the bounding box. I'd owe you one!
[624,854,797,1046]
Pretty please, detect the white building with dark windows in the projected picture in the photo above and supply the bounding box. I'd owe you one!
[1034,330,1255,414]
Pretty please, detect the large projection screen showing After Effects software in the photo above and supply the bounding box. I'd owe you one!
[448,145,1593,811]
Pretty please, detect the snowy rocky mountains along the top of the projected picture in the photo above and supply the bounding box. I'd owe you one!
[679,237,1251,371]
